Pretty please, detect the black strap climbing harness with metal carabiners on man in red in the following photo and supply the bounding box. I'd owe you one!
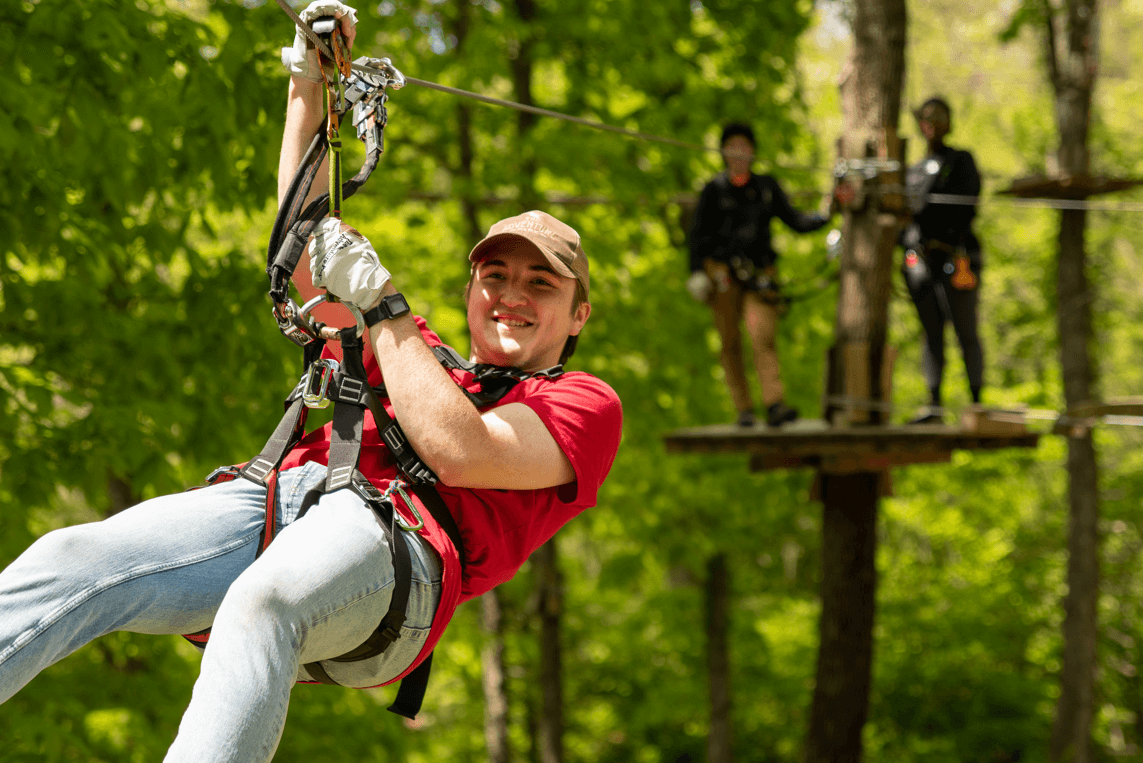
[185,17,563,718]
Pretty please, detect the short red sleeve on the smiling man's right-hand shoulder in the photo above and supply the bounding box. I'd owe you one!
[520,371,623,507]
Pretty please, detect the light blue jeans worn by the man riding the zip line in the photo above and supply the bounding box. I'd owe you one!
[0,464,441,763]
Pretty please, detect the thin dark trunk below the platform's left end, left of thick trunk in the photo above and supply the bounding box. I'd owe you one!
[706,554,732,763]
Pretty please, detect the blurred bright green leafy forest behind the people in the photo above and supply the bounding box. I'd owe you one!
[0,0,1143,763]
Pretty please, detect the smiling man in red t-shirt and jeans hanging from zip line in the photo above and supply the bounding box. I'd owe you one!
[0,2,622,762]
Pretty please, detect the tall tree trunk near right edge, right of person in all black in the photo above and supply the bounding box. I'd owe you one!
[1045,0,1100,763]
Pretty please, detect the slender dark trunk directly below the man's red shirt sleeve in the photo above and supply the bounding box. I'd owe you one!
[531,538,563,763]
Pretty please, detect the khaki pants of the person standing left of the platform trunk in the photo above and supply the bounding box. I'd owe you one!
[704,259,783,412]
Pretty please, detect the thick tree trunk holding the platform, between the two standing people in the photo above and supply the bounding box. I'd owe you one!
[805,0,906,763]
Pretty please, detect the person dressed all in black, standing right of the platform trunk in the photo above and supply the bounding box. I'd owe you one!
[901,97,984,424]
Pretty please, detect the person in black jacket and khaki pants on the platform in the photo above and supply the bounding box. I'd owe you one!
[687,123,829,426]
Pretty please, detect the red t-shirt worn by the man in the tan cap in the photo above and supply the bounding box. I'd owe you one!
[281,316,623,681]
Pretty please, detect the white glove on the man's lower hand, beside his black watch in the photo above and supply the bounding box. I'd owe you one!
[310,217,389,312]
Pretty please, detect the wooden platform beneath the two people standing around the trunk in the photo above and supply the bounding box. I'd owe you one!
[664,419,1040,474]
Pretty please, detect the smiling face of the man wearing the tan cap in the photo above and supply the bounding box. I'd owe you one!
[467,238,591,371]
